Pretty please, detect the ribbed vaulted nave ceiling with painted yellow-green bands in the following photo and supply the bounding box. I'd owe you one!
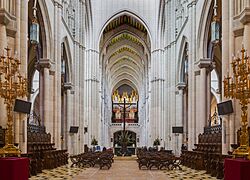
[100,15,150,94]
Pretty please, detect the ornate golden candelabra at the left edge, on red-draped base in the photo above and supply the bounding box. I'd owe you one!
[0,48,27,156]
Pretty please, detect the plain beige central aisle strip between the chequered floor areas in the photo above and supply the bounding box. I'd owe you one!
[73,159,170,180]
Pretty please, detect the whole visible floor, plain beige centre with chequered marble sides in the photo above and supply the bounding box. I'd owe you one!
[30,159,219,180]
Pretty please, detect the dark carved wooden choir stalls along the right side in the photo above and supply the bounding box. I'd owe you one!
[181,126,234,178]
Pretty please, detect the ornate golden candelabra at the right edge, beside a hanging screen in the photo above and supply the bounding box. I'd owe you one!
[223,48,250,159]
